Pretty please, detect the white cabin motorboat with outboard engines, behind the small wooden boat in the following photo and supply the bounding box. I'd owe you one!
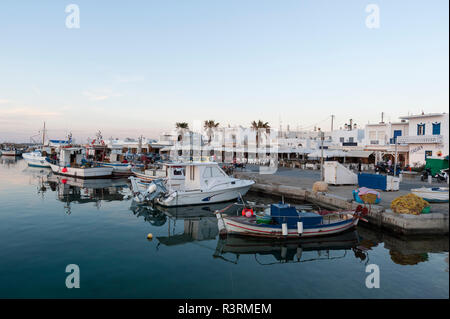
[132,162,255,207]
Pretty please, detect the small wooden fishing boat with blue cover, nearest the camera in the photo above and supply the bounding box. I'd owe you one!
[216,204,362,238]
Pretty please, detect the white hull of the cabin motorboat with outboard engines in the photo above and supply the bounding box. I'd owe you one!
[157,181,253,207]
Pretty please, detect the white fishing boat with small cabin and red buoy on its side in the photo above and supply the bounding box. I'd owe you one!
[48,147,113,178]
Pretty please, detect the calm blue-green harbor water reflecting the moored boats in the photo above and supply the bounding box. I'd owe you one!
[0,157,449,298]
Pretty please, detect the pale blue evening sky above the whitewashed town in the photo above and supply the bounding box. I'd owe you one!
[0,0,449,142]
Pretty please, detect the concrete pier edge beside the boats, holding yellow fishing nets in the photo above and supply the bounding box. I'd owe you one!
[234,169,449,235]
